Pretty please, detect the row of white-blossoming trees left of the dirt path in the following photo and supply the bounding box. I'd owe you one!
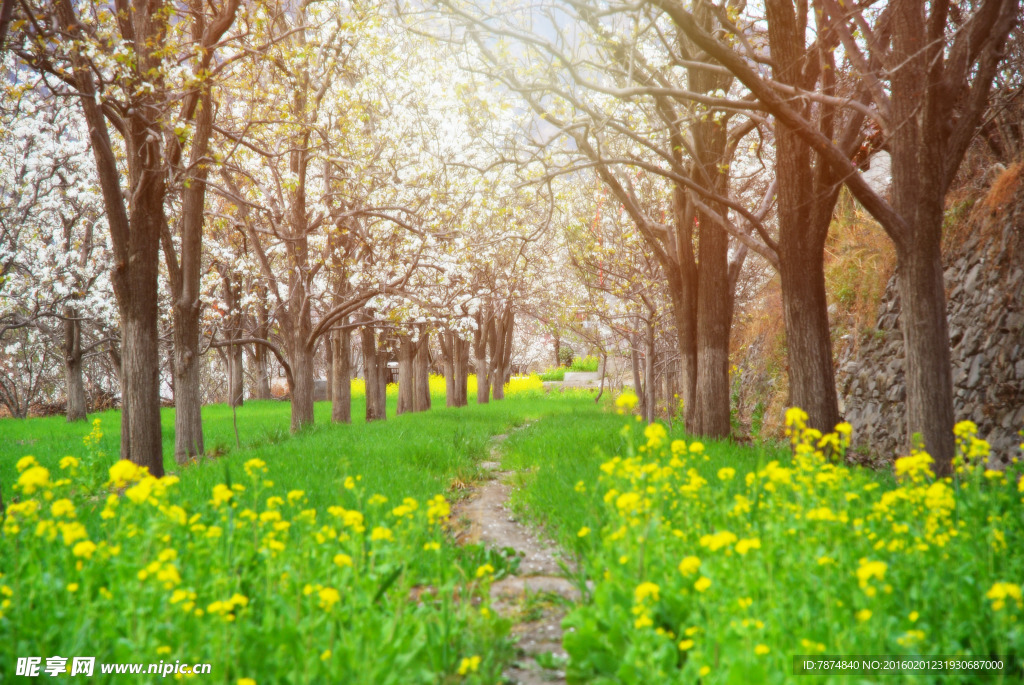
[0,0,573,475]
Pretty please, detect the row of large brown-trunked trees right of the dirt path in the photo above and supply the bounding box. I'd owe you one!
[421,0,1021,473]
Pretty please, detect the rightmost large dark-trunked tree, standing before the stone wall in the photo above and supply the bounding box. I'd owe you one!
[656,0,1020,474]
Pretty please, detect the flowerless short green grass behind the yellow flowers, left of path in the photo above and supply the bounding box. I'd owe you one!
[0,392,599,507]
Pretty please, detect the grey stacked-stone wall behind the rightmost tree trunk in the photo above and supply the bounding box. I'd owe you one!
[837,183,1024,464]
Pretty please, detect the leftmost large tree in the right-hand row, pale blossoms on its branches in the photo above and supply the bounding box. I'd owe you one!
[432,2,771,435]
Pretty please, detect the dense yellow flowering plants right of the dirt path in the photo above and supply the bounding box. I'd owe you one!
[567,409,1024,682]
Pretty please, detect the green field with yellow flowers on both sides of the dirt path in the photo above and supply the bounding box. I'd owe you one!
[0,379,1024,685]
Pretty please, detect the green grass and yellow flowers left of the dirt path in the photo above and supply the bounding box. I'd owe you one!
[0,390,599,685]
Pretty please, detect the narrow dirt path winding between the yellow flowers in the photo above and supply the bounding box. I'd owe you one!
[454,435,580,685]
